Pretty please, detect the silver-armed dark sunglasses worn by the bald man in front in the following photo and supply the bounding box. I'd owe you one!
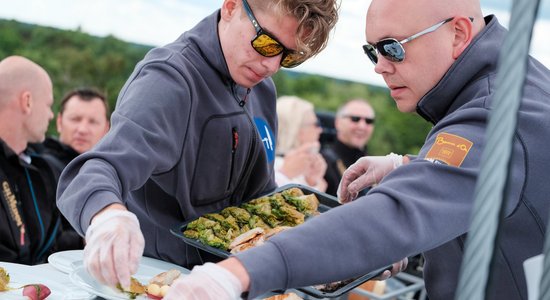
[363,17,474,65]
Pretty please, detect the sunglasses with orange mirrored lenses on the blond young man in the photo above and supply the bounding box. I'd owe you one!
[243,0,306,68]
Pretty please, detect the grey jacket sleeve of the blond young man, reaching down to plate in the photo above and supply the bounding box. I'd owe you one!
[57,60,192,235]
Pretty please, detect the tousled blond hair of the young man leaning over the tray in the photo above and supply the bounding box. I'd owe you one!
[248,0,339,58]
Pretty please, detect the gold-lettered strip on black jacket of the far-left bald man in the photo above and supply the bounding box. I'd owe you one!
[0,166,30,257]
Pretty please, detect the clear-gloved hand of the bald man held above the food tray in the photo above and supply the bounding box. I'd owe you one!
[337,153,403,203]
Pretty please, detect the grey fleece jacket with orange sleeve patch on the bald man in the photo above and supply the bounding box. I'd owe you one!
[237,16,550,300]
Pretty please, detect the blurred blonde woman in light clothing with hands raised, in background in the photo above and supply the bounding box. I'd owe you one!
[275,96,327,192]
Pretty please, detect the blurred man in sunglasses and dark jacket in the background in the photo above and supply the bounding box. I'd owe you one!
[321,99,375,196]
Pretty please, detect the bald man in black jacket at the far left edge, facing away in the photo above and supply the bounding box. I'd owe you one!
[0,56,72,265]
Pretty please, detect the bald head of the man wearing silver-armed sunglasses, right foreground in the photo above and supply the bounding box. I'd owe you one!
[366,0,485,112]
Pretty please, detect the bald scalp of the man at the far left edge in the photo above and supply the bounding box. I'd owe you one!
[0,56,51,109]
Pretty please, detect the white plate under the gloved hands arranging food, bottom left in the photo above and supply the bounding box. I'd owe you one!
[69,257,189,300]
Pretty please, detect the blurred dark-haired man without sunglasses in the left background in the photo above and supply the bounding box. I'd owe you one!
[39,88,109,171]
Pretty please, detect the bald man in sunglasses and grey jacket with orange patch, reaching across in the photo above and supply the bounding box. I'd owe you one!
[163,0,550,300]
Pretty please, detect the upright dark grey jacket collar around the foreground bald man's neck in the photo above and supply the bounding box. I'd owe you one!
[416,15,507,124]
